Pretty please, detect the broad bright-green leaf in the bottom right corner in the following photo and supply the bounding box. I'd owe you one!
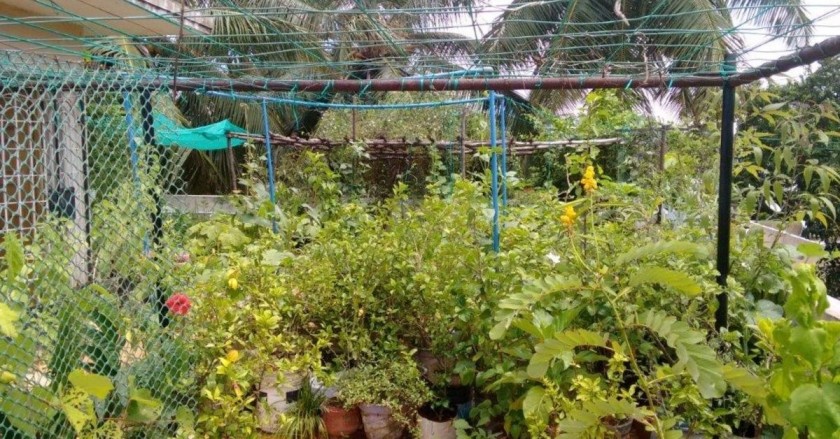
[790,383,840,438]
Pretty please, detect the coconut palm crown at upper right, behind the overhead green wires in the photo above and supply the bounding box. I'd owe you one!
[482,0,812,118]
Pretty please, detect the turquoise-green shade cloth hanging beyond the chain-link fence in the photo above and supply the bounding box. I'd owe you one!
[154,113,247,151]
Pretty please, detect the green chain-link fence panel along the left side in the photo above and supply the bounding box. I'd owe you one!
[0,53,195,438]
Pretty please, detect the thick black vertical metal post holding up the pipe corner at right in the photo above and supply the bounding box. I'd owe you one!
[715,54,736,330]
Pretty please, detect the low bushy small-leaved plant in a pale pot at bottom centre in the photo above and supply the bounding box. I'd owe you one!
[338,355,431,439]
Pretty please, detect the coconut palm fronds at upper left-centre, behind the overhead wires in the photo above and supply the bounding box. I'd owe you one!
[143,0,478,190]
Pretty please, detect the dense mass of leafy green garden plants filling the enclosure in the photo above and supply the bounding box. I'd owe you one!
[0,79,840,439]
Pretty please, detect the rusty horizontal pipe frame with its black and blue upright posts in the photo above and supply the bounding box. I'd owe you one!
[118,36,840,330]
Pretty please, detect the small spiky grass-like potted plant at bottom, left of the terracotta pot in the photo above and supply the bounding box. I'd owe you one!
[279,378,327,439]
